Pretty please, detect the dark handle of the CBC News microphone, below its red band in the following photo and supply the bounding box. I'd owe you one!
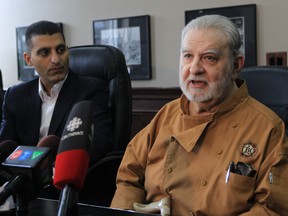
[57,184,79,216]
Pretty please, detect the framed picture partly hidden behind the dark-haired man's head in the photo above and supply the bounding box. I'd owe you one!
[16,23,63,81]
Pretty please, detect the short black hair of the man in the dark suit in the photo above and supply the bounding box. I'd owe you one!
[25,20,65,51]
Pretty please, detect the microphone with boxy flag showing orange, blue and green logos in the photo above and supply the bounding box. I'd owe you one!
[0,135,60,213]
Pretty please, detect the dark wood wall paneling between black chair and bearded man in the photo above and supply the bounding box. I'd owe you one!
[131,88,182,138]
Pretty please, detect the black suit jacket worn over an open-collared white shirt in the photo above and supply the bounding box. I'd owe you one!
[0,71,112,162]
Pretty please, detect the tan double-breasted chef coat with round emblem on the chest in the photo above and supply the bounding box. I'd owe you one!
[111,80,288,216]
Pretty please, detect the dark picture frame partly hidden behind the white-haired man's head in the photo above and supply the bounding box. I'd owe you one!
[185,4,257,67]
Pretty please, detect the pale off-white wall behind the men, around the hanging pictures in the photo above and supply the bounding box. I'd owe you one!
[0,0,288,88]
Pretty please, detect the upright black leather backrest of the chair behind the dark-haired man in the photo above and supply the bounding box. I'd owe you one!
[69,45,132,151]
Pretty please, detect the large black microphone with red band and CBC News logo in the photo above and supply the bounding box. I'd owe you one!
[54,101,92,216]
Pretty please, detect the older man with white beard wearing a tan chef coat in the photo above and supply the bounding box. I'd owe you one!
[111,15,288,216]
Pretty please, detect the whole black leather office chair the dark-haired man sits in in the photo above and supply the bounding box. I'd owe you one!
[69,45,132,206]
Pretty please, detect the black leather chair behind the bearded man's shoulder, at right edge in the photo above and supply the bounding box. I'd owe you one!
[240,66,288,134]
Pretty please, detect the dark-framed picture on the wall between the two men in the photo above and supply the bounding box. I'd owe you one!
[93,15,151,80]
